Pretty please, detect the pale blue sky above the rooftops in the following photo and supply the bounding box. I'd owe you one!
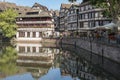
[0,0,82,10]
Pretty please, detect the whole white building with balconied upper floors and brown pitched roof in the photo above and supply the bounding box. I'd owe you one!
[16,3,54,41]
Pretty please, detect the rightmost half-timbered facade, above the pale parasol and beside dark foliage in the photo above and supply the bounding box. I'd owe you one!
[79,3,111,28]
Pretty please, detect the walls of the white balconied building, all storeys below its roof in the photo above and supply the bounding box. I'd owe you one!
[16,15,54,41]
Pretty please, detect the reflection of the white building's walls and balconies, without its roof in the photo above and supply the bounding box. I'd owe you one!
[16,44,54,67]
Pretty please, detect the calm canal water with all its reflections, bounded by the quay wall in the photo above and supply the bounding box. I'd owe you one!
[0,43,120,80]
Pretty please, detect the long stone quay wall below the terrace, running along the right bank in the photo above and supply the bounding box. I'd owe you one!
[60,38,120,63]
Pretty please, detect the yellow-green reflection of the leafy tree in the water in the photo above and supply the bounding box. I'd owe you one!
[0,46,18,78]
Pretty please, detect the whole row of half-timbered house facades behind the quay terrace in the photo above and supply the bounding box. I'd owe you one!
[60,2,111,31]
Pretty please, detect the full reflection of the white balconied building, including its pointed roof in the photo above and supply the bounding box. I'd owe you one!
[16,43,58,78]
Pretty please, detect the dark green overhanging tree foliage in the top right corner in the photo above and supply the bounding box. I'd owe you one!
[90,0,120,24]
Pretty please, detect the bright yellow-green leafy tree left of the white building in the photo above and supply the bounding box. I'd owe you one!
[0,9,17,38]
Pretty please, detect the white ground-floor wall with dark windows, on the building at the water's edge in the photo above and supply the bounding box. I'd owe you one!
[16,28,54,41]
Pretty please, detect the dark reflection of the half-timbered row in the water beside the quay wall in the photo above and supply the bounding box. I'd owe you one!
[60,52,109,80]
